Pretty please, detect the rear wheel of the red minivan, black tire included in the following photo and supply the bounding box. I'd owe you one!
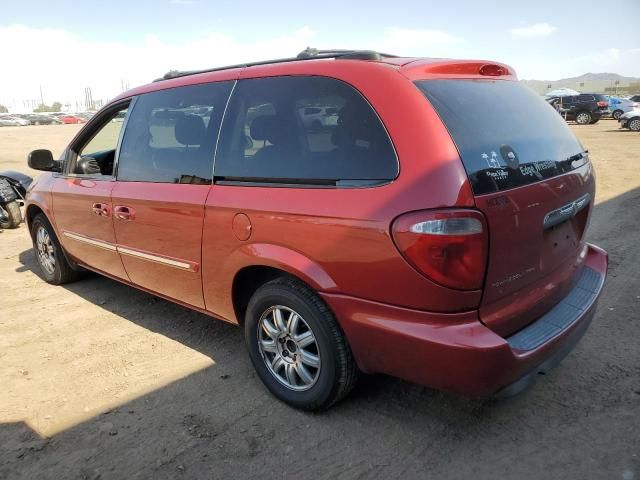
[245,277,358,411]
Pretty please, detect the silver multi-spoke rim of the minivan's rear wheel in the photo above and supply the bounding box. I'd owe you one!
[258,305,321,391]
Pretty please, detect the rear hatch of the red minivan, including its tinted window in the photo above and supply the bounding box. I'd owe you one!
[416,79,594,336]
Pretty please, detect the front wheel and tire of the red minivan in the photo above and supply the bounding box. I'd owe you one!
[31,213,78,285]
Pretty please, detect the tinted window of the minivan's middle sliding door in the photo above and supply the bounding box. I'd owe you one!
[117,81,233,184]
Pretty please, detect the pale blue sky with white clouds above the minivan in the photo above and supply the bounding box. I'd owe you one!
[0,0,640,110]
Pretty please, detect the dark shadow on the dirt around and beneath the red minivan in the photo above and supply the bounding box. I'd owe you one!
[0,189,640,479]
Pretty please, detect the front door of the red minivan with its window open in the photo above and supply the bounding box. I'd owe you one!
[51,103,128,279]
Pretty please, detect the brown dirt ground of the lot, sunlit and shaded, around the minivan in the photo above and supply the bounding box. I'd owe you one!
[0,120,640,480]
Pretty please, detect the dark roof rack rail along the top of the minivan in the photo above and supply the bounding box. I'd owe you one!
[154,47,396,82]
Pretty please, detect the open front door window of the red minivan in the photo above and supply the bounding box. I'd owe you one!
[69,106,129,177]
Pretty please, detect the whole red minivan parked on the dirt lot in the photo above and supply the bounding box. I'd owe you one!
[27,50,607,410]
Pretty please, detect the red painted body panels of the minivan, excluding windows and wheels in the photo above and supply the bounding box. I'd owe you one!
[27,54,607,395]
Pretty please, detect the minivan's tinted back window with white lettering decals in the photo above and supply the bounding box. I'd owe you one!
[416,79,587,195]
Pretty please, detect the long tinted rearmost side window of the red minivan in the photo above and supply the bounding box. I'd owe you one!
[214,76,398,186]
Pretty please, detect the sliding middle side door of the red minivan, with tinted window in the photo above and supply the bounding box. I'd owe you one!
[111,82,232,308]
